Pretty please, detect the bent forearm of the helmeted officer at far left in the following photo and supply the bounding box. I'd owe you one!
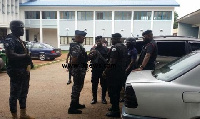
[6,50,28,60]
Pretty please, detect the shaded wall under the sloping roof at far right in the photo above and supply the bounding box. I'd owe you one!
[178,23,199,38]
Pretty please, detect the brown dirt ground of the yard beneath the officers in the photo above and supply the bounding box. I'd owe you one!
[0,55,122,119]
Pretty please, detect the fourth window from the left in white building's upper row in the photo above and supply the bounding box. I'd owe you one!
[78,12,93,20]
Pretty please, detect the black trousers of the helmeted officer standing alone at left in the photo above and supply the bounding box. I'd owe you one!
[7,69,30,113]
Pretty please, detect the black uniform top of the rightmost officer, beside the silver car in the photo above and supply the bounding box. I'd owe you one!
[138,40,158,70]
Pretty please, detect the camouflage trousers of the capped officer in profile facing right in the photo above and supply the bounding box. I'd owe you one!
[70,71,86,108]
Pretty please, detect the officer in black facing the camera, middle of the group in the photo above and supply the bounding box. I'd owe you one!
[88,36,108,104]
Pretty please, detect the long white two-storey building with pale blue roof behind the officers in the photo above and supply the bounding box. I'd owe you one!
[1,0,179,50]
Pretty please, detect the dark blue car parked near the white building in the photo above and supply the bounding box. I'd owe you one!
[26,42,61,60]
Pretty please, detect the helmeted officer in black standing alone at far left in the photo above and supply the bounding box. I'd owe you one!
[4,20,33,119]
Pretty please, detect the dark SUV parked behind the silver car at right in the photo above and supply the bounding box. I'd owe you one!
[136,36,200,67]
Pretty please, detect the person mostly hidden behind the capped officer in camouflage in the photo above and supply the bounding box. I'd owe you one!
[66,38,75,85]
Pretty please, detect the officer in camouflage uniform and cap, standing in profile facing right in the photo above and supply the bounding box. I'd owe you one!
[68,30,88,114]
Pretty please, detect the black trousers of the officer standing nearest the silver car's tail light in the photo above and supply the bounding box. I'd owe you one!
[108,84,121,111]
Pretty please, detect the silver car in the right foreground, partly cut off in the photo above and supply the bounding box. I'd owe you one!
[122,50,200,119]
